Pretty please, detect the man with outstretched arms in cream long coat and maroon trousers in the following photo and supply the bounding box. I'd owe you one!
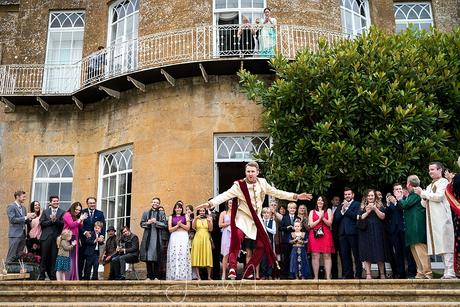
[199,162,312,279]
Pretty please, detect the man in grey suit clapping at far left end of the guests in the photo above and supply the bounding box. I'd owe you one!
[6,191,36,262]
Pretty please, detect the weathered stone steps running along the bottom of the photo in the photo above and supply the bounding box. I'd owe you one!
[0,279,460,307]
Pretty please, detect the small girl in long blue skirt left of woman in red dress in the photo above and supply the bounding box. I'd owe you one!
[289,220,310,279]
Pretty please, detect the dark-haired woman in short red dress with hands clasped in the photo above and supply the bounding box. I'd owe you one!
[308,196,335,279]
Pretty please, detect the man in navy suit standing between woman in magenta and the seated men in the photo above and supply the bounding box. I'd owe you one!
[78,196,106,280]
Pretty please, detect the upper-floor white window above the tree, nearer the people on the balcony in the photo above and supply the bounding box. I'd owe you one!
[340,0,371,37]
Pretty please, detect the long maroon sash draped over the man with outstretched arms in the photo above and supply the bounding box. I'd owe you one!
[230,180,276,265]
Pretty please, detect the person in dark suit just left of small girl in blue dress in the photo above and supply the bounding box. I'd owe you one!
[280,202,299,278]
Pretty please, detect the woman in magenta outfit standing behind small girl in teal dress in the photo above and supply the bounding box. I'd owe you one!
[63,201,88,280]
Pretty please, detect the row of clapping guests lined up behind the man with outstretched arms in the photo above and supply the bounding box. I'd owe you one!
[7,162,460,280]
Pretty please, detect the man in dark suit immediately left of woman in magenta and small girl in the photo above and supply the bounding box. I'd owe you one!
[39,195,64,280]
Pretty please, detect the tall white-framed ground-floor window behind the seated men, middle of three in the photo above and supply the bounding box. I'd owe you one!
[98,146,133,229]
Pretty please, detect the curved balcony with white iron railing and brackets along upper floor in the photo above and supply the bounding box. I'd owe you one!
[0,25,346,109]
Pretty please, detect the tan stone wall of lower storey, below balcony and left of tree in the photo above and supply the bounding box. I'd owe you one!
[0,76,262,258]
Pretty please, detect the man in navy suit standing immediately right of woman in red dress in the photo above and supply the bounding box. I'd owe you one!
[334,188,363,279]
